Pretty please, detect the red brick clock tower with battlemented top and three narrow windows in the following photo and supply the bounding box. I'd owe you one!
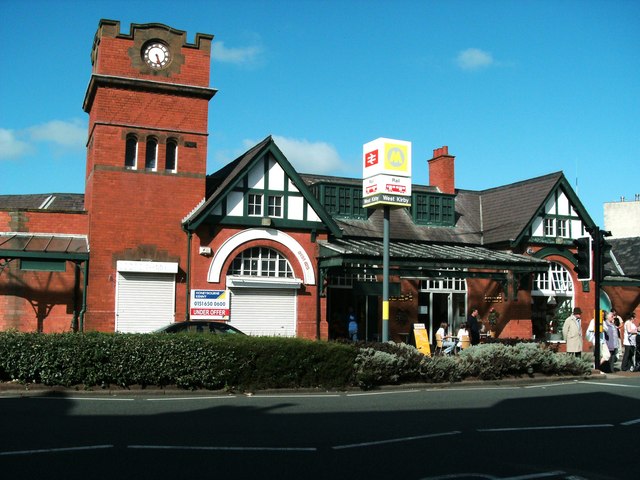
[83,20,216,332]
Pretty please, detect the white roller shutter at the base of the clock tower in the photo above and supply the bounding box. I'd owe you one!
[116,272,175,333]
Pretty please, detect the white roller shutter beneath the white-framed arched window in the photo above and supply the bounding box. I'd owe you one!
[229,288,297,337]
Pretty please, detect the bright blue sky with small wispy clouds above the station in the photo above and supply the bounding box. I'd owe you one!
[0,0,640,226]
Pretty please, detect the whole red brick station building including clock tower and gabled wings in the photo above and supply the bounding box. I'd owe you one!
[0,20,640,340]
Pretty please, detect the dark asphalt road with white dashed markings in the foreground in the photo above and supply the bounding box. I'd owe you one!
[0,374,640,479]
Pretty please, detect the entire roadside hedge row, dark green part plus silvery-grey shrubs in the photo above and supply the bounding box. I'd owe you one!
[0,332,591,391]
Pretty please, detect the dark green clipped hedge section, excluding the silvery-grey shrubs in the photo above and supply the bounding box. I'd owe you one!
[0,332,357,390]
